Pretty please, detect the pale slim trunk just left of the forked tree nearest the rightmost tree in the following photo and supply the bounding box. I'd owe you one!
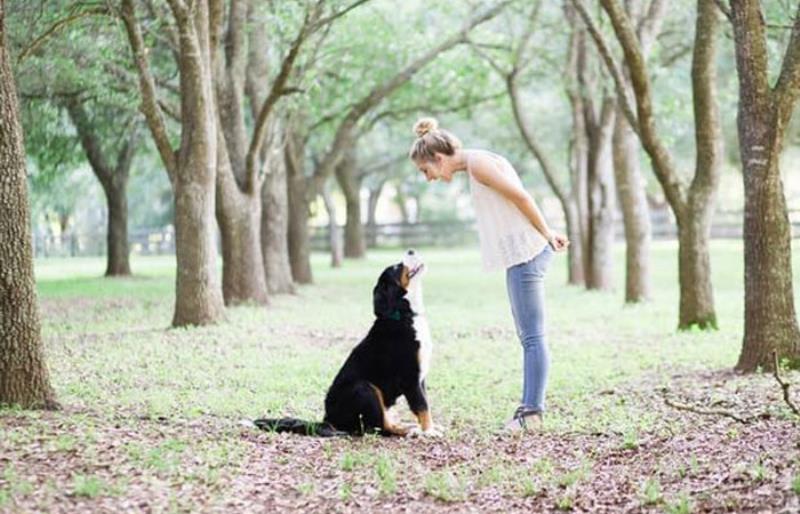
[613,108,652,303]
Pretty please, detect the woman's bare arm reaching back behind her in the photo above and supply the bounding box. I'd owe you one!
[470,155,569,250]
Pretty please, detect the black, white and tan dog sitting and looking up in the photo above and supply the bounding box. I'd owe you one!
[254,250,441,437]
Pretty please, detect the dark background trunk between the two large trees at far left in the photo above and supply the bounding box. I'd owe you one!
[103,176,131,277]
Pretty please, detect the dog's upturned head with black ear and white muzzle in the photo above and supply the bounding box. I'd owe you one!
[372,250,425,320]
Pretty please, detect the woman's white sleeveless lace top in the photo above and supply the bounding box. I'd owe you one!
[466,150,547,271]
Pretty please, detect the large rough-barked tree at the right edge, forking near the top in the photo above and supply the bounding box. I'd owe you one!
[721,0,800,372]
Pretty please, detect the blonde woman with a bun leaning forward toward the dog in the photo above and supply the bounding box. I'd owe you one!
[409,118,569,431]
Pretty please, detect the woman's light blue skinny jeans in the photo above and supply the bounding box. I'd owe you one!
[506,245,554,412]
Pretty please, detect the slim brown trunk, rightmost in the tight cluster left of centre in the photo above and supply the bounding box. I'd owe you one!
[284,133,314,284]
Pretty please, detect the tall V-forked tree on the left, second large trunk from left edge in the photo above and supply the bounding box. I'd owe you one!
[121,0,224,326]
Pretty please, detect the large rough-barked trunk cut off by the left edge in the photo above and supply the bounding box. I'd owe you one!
[0,6,58,408]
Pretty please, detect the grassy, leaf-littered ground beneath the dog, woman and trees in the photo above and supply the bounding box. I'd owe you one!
[0,242,800,513]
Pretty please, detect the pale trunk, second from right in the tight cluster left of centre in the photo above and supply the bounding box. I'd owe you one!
[261,137,295,294]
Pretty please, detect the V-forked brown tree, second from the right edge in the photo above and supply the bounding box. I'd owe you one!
[572,0,721,329]
